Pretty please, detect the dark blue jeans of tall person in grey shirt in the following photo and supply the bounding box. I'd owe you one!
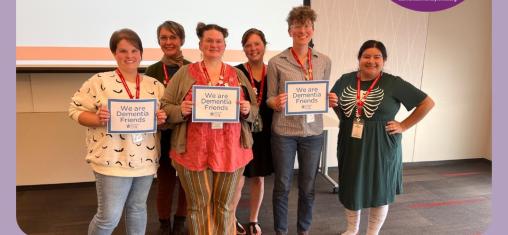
[271,133,323,233]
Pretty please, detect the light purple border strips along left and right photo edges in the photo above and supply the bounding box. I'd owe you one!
[6,0,508,234]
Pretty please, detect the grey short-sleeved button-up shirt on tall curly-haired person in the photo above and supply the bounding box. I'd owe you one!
[267,48,332,137]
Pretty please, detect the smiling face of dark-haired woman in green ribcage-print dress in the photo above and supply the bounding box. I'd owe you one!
[358,48,385,79]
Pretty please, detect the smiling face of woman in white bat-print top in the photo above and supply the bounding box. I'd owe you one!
[114,39,141,72]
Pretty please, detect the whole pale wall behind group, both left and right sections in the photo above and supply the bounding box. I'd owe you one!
[16,0,492,185]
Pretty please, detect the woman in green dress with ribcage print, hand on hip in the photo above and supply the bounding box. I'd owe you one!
[332,40,434,235]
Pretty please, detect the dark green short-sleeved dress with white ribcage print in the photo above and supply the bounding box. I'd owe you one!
[332,72,427,210]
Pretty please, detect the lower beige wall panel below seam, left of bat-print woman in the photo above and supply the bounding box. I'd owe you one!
[16,112,94,185]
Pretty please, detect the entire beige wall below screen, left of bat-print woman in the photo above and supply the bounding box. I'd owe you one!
[16,73,94,185]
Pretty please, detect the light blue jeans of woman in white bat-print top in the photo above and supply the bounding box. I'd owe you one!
[88,172,153,235]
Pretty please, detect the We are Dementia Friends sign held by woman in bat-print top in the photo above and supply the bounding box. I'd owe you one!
[108,99,157,133]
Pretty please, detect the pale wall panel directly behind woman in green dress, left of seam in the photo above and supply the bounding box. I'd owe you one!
[311,0,429,162]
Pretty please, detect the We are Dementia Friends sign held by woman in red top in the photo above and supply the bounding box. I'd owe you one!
[192,85,240,122]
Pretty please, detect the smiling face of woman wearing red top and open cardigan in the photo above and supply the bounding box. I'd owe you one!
[199,29,226,59]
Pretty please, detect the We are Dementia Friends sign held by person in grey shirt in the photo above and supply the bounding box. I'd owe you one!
[285,81,328,116]
